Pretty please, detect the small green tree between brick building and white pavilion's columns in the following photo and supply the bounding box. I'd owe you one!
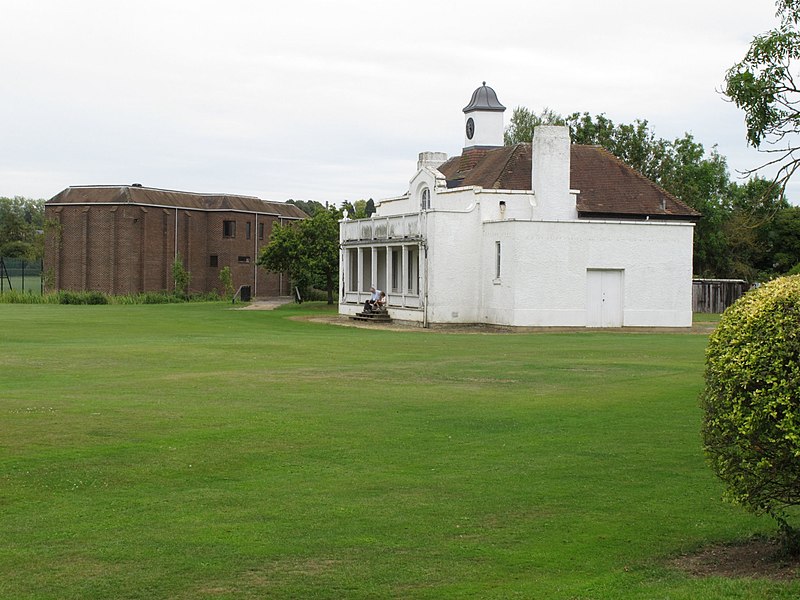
[258,207,341,304]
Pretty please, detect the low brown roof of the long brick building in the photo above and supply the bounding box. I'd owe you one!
[46,185,308,219]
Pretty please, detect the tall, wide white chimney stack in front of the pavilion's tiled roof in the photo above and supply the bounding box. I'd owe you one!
[531,125,578,221]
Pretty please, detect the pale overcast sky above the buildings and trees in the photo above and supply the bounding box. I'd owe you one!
[0,0,788,204]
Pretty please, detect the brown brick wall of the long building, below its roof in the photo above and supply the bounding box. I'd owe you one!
[44,204,291,296]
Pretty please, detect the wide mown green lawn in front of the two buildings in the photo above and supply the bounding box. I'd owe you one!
[0,304,800,600]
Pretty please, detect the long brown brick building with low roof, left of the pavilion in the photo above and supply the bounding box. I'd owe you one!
[44,184,306,296]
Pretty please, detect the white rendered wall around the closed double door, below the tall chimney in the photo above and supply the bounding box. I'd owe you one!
[482,221,693,327]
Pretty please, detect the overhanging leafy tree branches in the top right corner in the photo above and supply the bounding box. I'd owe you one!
[724,0,800,189]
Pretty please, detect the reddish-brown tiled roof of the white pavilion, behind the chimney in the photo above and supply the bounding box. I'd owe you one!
[438,144,700,221]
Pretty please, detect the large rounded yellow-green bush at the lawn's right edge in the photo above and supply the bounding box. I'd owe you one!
[701,276,800,544]
